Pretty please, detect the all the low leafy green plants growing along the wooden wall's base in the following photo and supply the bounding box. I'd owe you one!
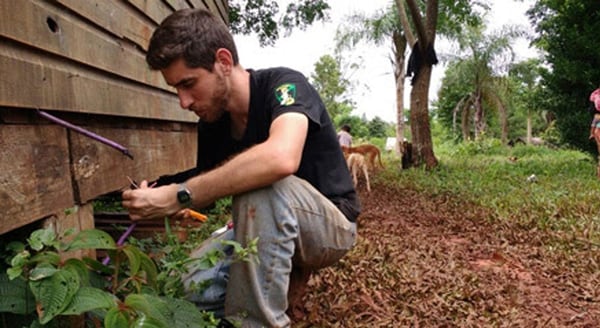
[0,221,256,327]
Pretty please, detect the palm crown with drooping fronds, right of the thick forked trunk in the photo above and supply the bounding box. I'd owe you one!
[438,22,522,142]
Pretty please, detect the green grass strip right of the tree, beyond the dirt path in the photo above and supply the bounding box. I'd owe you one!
[383,139,600,244]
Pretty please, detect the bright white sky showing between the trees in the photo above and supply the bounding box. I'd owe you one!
[234,0,536,123]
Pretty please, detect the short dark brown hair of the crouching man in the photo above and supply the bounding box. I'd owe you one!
[146,9,239,72]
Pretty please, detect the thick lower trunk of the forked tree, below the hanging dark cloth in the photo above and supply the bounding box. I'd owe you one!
[410,63,438,169]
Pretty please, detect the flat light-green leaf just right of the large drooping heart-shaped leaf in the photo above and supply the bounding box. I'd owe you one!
[60,287,117,315]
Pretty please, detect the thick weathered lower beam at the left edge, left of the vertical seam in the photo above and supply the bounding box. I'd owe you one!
[0,124,74,234]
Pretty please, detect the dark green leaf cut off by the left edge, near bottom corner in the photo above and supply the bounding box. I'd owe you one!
[0,273,35,314]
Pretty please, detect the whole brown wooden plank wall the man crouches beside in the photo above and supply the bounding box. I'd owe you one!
[0,0,228,234]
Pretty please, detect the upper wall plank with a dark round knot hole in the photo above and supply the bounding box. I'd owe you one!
[0,0,171,90]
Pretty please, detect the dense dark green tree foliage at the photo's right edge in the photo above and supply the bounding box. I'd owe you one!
[528,0,600,150]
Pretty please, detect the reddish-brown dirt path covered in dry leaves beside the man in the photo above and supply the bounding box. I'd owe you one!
[294,181,600,327]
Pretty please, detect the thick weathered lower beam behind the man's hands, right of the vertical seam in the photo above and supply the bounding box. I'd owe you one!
[69,115,196,203]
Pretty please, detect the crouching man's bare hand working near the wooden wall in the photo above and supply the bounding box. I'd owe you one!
[122,180,184,221]
